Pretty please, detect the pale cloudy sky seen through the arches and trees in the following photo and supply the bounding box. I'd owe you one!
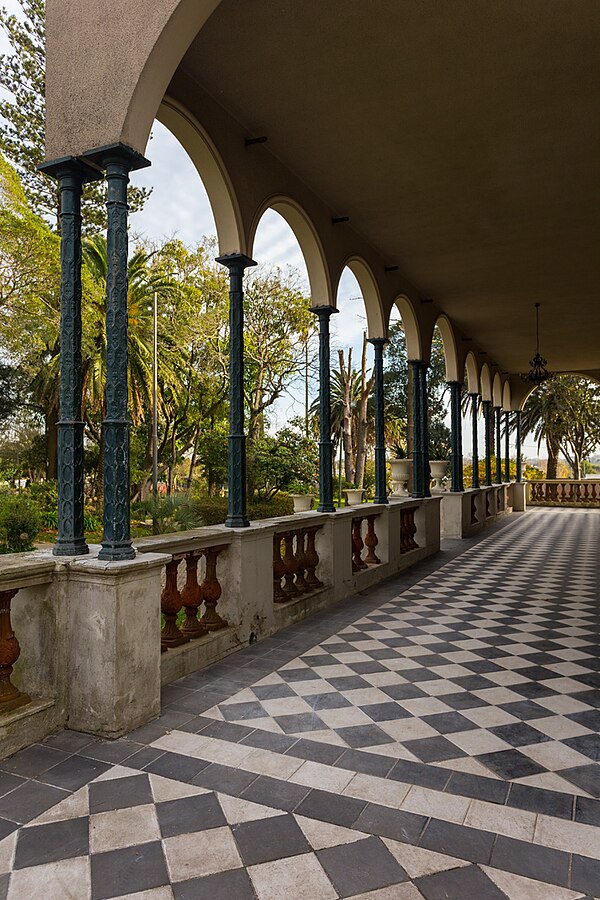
[0,0,538,457]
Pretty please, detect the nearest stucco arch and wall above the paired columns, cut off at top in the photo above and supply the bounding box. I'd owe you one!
[46,0,220,159]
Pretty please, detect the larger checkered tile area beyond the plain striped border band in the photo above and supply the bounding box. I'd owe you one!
[205,510,600,797]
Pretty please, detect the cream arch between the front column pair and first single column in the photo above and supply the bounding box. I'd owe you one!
[156,97,246,254]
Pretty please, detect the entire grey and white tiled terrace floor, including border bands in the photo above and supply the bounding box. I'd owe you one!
[0,509,600,900]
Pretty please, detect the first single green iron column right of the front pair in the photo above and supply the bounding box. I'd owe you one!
[217,253,256,528]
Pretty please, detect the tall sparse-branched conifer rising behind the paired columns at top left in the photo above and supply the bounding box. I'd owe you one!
[0,0,149,232]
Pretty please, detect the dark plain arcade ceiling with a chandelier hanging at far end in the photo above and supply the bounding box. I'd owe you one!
[170,0,600,372]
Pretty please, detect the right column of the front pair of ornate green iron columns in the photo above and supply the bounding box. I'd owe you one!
[84,144,150,561]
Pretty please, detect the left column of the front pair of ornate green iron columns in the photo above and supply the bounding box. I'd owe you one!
[40,157,95,556]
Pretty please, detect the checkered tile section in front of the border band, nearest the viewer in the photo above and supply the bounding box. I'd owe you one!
[0,767,583,900]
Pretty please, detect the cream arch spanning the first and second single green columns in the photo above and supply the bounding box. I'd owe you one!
[248,195,335,306]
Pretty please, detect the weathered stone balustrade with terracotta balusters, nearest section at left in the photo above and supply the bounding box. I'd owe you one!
[0,496,441,756]
